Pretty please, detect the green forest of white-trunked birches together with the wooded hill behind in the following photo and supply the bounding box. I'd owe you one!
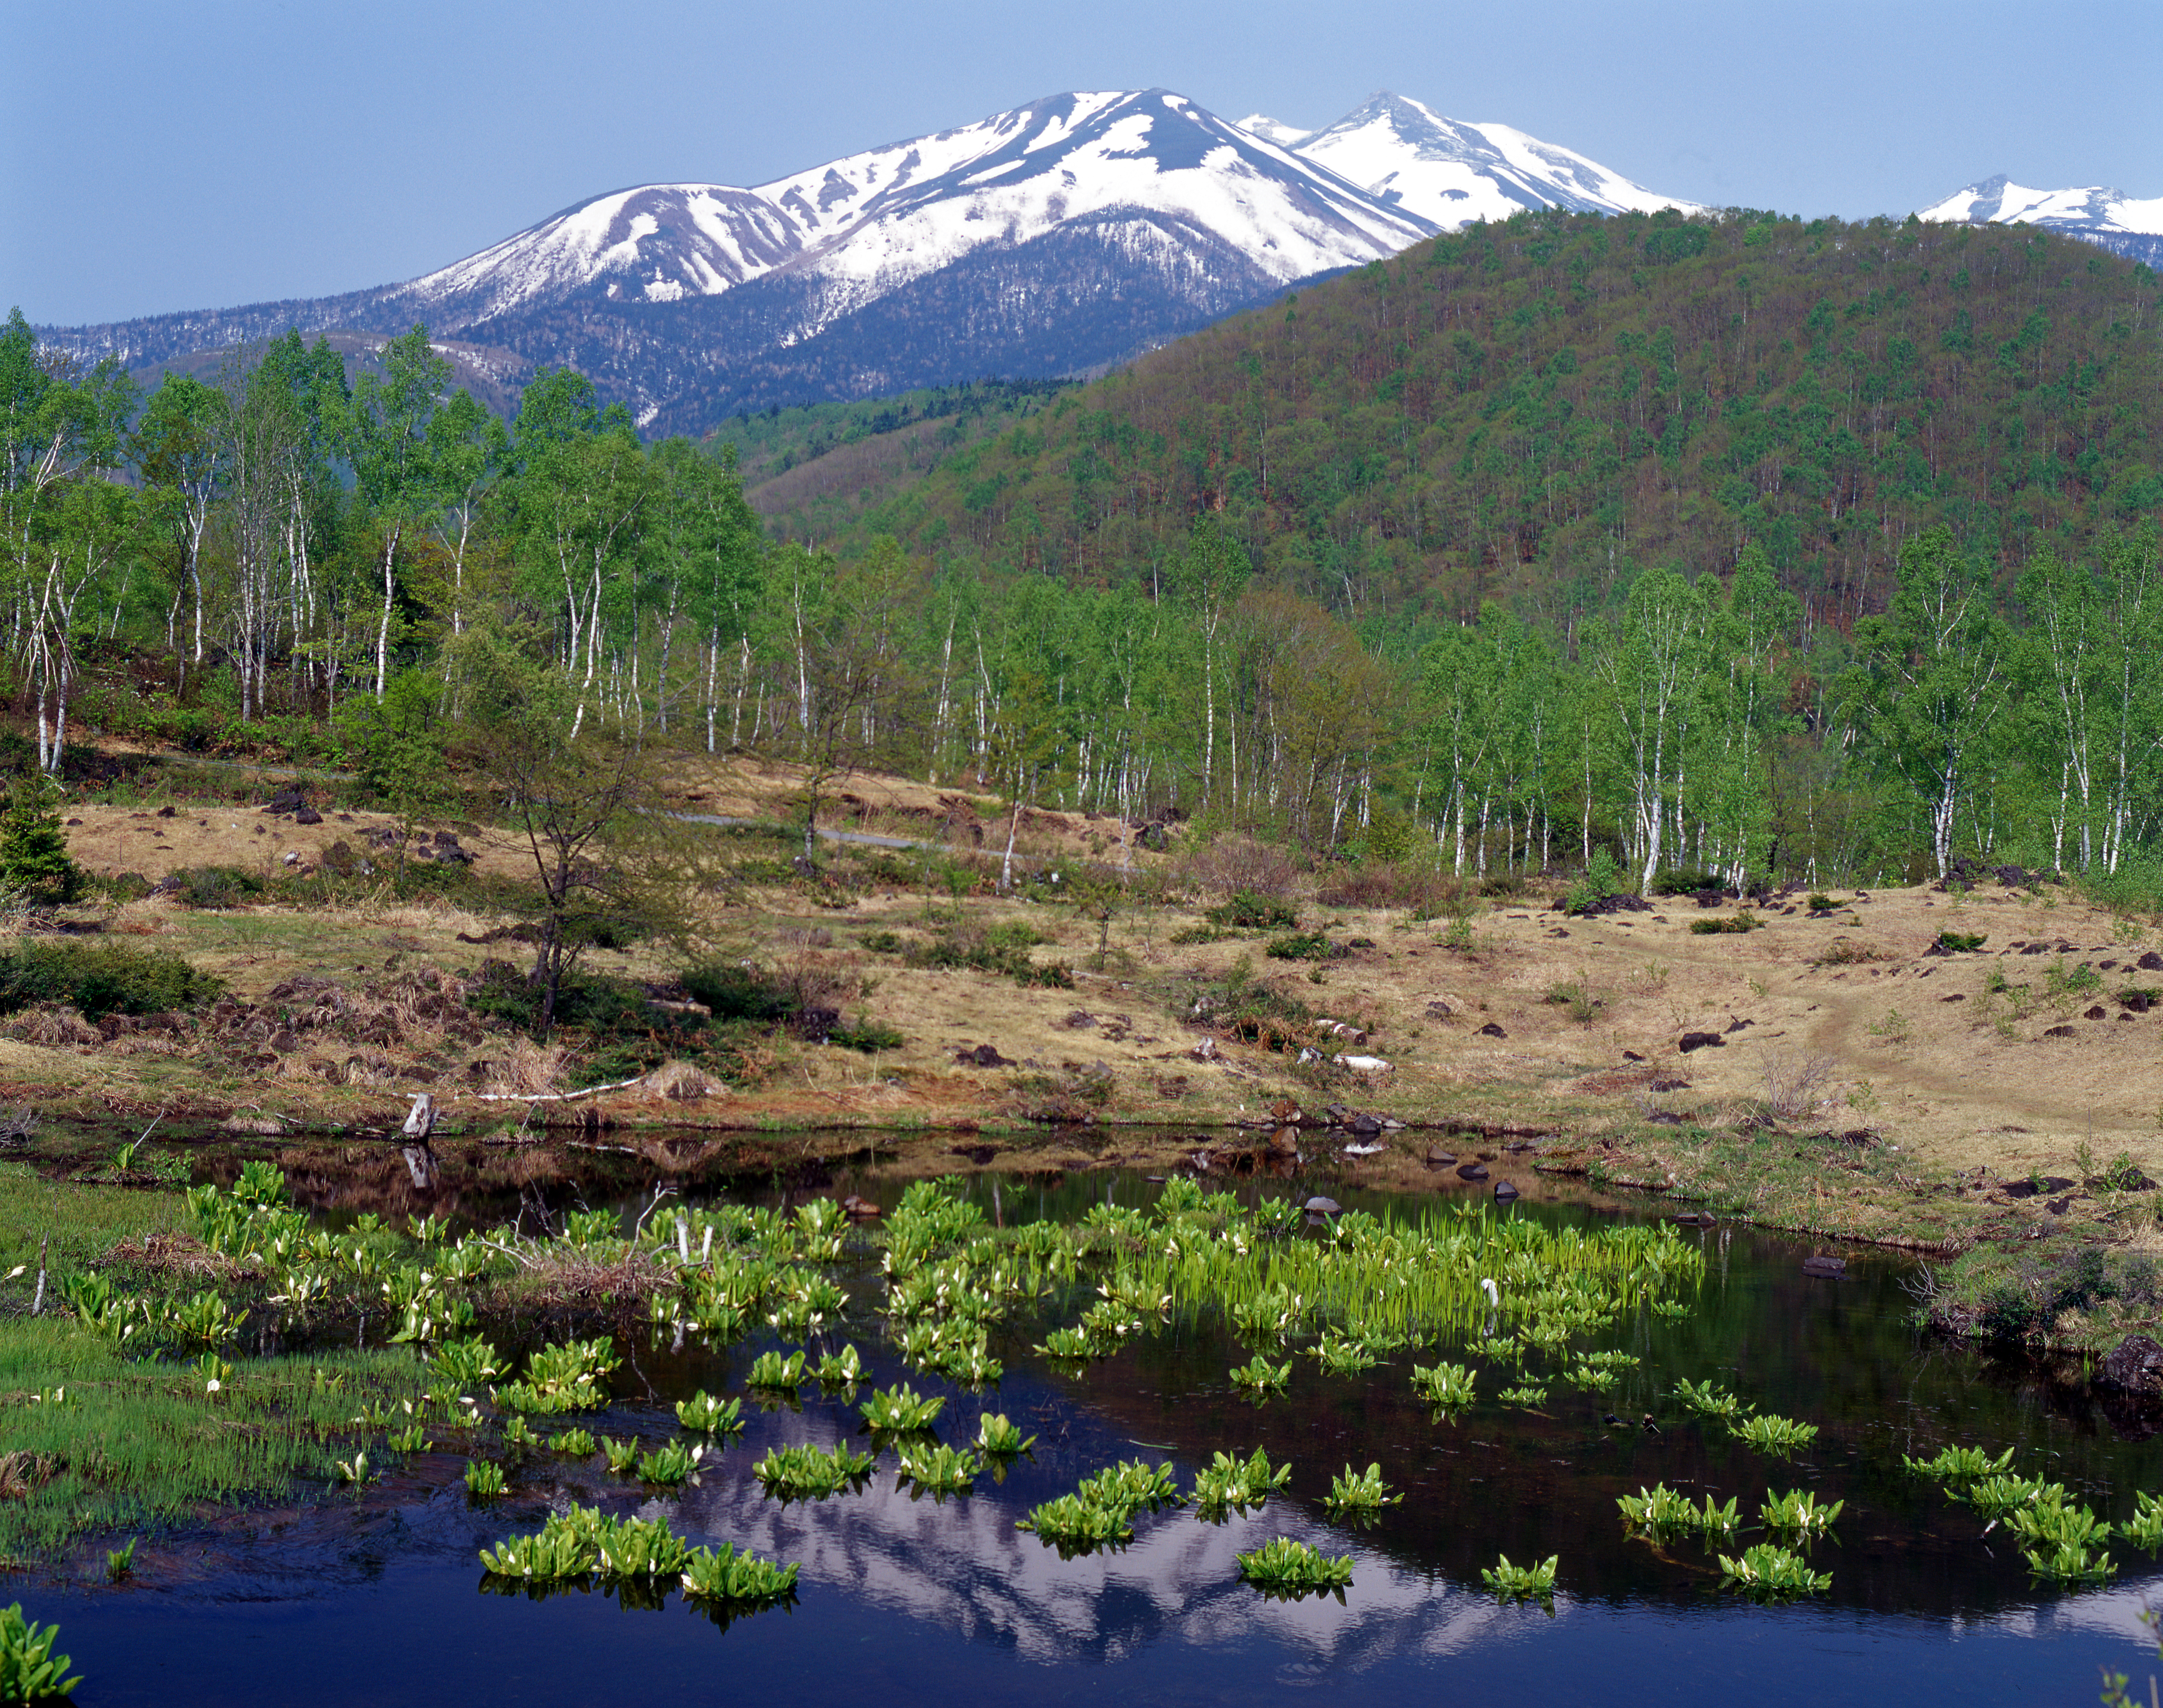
[0,210,2163,887]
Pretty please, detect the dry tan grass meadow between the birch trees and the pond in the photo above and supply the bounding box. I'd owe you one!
[17,763,2163,1243]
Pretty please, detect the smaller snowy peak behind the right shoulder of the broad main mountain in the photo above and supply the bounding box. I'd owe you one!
[1242,89,1698,229]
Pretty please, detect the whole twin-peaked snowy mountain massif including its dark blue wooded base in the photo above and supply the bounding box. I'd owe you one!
[29,89,1687,430]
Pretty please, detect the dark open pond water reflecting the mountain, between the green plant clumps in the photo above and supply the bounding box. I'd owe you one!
[9,1168,2163,1708]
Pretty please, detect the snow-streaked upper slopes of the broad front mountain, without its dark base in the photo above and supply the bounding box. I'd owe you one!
[385,89,1430,337]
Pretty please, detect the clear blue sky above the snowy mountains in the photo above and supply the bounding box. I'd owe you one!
[0,0,2163,324]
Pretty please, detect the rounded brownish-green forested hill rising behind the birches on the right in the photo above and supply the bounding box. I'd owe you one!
[785,210,2163,627]
